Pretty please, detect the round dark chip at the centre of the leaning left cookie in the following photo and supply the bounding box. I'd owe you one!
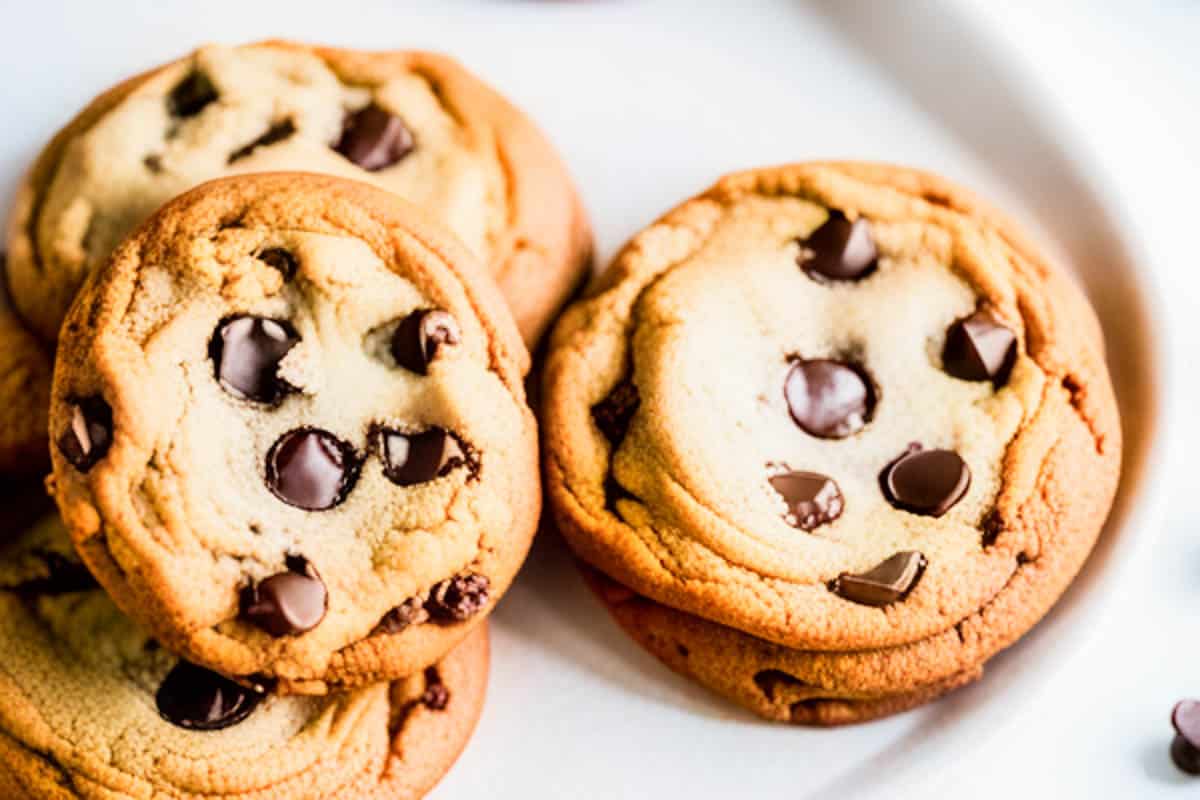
[266,428,359,511]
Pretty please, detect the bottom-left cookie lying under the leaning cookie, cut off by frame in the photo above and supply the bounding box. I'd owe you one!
[0,517,488,800]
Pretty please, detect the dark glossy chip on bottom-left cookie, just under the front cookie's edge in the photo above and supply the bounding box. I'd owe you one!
[155,661,263,730]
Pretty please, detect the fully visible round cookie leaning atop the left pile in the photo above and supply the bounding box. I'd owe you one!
[50,174,540,693]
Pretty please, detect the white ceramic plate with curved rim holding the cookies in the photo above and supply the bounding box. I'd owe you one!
[0,0,1168,800]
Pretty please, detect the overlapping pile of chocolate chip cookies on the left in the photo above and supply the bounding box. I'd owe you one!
[0,42,589,800]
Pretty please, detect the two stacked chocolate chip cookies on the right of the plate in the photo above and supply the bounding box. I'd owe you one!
[542,163,1121,722]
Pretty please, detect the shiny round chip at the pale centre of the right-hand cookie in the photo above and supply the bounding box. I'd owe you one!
[784,359,875,439]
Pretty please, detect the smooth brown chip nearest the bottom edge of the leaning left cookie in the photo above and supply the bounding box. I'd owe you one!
[241,555,329,637]
